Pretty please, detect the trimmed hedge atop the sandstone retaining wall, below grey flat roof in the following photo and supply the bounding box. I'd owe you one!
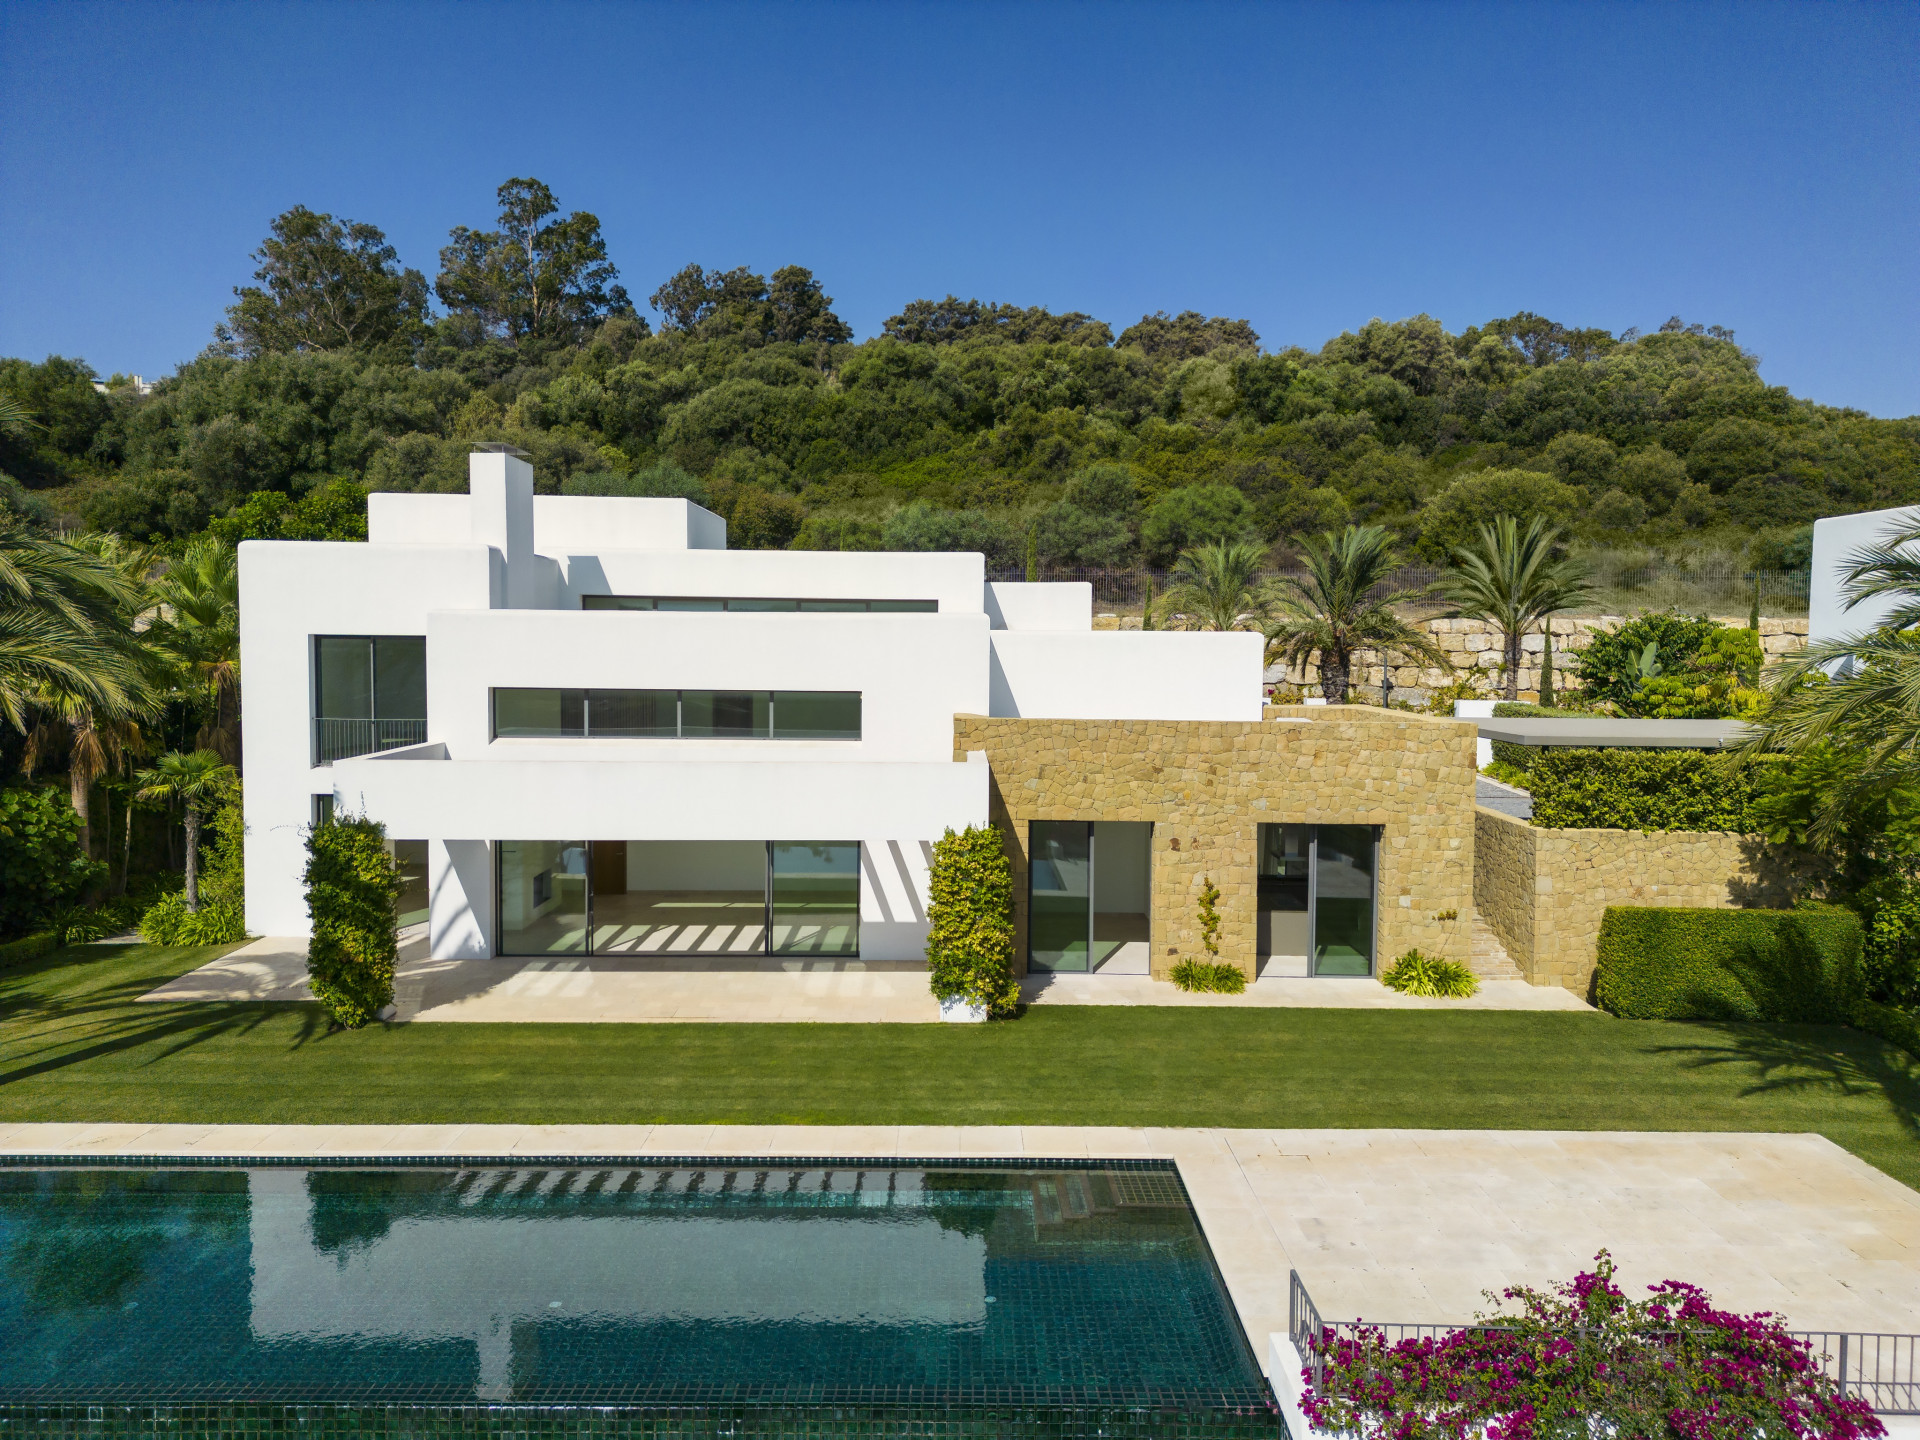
[1494,739,1768,835]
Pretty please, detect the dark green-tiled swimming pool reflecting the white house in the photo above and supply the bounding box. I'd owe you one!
[0,1158,1281,1434]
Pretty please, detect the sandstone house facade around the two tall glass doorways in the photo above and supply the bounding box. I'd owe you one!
[954,705,1475,977]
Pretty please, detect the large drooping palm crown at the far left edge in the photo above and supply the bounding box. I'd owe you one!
[0,526,144,732]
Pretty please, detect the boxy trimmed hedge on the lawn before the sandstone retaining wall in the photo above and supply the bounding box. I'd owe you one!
[1594,904,1866,1025]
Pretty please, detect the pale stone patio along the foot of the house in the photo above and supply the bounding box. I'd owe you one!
[140,933,1592,1023]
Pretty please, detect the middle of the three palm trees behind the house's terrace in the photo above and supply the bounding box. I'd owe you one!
[1265,524,1452,705]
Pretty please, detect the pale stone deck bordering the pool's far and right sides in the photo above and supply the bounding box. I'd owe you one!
[0,1125,1920,1365]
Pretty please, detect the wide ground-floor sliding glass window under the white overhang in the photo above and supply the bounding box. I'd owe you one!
[497,841,860,956]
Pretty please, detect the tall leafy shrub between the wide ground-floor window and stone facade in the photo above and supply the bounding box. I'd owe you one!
[927,826,1020,1014]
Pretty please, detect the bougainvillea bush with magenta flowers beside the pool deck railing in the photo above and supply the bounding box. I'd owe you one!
[1302,1250,1885,1440]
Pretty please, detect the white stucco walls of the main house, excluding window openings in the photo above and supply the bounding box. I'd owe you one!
[240,453,1261,958]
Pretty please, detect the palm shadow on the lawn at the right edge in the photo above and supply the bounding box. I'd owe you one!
[1649,1021,1920,1140]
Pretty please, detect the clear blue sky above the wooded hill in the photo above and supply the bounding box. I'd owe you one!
[0,0,1920,415]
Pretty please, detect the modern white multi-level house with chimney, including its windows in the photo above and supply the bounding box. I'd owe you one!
[240,453,1261,960]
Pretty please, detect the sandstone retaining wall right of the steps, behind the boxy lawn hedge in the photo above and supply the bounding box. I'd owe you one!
[1473,808,1793,998]
